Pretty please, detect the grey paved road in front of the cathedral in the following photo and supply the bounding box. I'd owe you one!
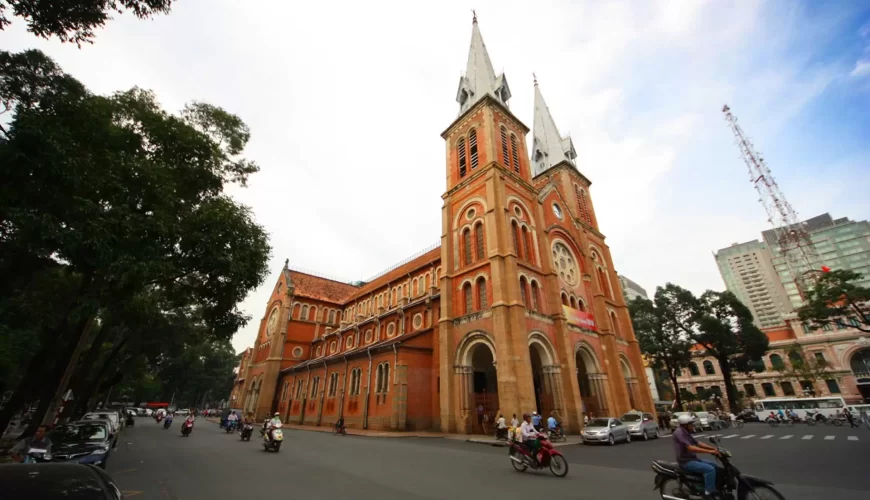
[108,418,870,500]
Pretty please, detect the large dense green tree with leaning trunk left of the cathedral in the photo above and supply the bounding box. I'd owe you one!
[0,51,270,436]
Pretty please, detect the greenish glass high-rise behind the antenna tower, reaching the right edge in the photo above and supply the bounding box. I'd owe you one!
[761,213,870,308]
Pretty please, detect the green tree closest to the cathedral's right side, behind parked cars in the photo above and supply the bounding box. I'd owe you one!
[628,283,693,407]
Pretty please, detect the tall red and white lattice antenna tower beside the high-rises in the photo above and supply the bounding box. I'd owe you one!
[722,104,821,298]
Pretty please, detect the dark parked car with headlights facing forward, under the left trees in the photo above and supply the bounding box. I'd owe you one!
[48,420,114,469]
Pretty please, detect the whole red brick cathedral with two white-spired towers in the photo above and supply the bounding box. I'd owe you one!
[230,19,653,433]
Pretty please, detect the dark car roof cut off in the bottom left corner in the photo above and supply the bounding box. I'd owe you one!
[0,463,123,500]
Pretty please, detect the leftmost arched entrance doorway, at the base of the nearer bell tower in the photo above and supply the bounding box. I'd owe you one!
[455,332,499,433]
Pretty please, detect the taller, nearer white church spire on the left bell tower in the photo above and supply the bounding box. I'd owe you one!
[456,14,511,114]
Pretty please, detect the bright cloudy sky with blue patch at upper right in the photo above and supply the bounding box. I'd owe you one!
[0,0,870,350]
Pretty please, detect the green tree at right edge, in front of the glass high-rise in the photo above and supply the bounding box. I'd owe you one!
[798,269,870,333]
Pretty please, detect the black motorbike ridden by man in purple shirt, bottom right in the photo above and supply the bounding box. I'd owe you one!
[652,436,785,500]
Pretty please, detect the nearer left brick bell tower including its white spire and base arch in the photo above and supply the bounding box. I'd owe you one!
[438,16,541,432]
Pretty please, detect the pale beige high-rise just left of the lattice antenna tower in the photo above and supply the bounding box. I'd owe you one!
[715,240,793,328]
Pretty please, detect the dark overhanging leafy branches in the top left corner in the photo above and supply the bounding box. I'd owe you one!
[0,0,172,45]
